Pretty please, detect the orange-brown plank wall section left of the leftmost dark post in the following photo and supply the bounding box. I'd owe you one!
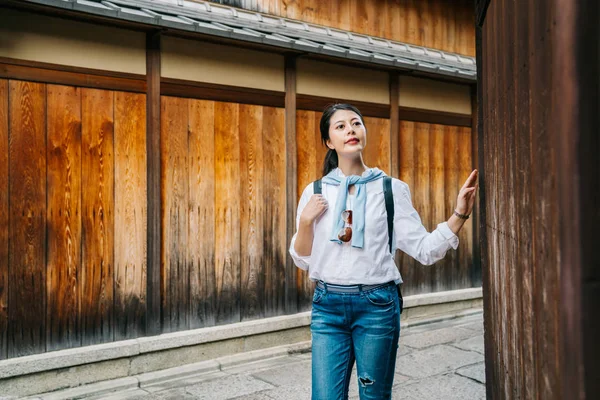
[0,80,146,358]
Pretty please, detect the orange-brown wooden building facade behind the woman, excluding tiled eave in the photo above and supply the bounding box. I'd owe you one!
[0,0,481,359]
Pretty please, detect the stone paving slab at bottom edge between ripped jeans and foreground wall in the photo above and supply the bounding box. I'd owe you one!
[392,374,485,400]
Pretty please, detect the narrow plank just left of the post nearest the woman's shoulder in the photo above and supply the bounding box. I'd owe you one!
[263,107,287,316]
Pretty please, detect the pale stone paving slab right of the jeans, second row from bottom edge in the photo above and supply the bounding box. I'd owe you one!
[396,345,483,378]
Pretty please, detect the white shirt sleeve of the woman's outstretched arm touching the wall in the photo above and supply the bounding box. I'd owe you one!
[392,179,458,265]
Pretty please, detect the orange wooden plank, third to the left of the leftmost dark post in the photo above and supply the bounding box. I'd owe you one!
[46,85,81,351]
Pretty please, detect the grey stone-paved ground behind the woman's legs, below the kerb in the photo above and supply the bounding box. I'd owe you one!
[100,314,485,400]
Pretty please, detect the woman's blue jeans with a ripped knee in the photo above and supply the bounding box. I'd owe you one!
[310,283,401,400]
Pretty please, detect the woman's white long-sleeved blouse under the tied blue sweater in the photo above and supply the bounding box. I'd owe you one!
[289,168,458,285]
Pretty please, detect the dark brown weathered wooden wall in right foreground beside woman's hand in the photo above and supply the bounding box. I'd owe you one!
[477,0,600,400]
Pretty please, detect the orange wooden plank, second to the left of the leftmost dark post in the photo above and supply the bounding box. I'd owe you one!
[79,89,114,346]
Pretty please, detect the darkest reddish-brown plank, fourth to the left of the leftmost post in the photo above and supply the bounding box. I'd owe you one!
[8,81,46,357]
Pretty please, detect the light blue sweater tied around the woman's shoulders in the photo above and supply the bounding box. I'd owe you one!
[322,168,385,249]
